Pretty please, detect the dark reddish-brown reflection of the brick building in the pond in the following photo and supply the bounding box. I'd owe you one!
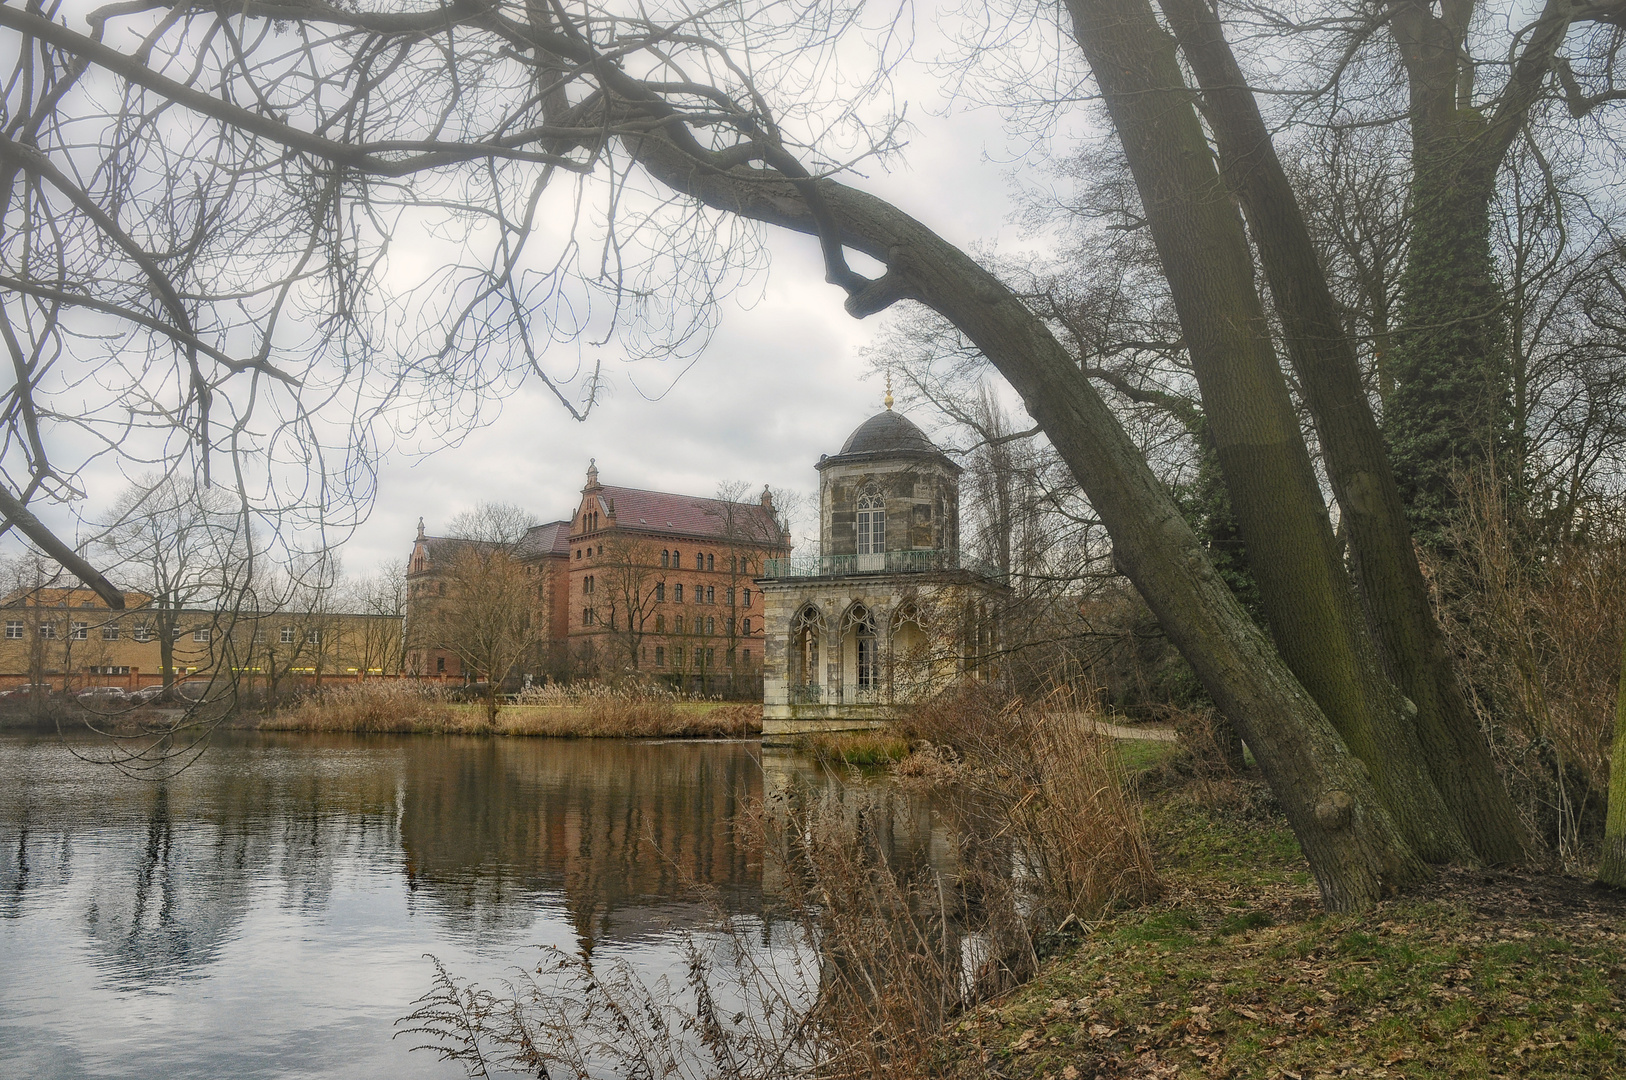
[402,740,763,952]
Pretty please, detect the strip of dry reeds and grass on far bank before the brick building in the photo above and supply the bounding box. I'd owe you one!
[259,685,763,738]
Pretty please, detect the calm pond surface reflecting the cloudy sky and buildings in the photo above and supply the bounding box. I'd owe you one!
[0,735,930,1080]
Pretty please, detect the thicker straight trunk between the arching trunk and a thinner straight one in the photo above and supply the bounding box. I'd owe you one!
[1068,0,1472,862]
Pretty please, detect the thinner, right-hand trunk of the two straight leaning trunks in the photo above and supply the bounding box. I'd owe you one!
[1159,0,1524,862]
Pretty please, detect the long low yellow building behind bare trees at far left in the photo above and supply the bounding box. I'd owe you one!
[0,589,402,690]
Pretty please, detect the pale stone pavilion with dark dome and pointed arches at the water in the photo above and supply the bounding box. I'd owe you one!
[758,394,1006,740]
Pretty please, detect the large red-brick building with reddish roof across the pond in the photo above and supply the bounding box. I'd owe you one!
[407,465,789,693]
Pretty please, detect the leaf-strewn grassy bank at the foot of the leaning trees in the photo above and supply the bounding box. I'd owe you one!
[945,781,1626,1080]
